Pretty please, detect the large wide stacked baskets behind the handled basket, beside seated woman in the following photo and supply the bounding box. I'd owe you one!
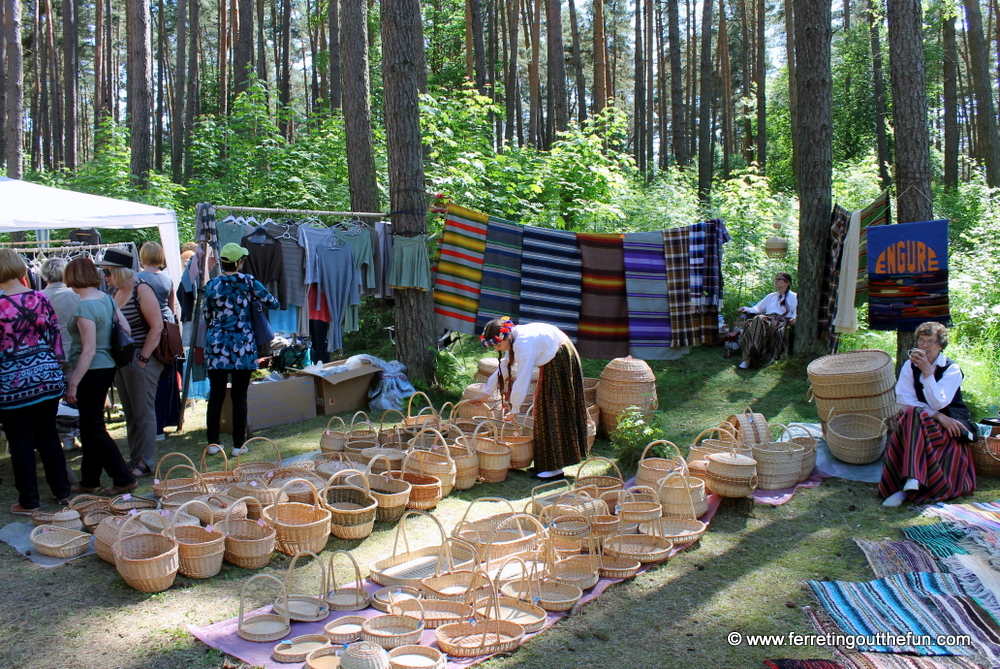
[806,349,896,426]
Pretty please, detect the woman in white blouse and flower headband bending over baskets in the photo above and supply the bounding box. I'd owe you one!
[474,317,587,478]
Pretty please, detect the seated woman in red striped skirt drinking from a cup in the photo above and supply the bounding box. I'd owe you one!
[878,322,976,506]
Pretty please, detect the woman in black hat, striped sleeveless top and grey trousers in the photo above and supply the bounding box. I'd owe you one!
[97,249,163,478]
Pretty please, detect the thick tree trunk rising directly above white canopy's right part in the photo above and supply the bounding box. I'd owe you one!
[127,0,153,190]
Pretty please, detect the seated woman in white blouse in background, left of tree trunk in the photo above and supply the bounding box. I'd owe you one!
[738,272,799,369]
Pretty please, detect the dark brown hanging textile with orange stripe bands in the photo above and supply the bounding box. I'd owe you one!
[576,232,629,359]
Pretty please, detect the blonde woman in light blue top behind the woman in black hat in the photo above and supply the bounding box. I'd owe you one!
[135,242,184,441]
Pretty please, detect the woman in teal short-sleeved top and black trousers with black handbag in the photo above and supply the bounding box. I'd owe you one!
[63,257,138,496]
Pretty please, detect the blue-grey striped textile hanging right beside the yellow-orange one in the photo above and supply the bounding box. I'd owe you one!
[476,216,523,331]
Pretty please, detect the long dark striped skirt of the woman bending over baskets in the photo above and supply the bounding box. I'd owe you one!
[534,342,587,471]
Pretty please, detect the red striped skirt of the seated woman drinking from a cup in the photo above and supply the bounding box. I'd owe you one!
[878,407,976,504]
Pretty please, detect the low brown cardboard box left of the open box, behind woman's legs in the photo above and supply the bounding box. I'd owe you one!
[221,376,316,434]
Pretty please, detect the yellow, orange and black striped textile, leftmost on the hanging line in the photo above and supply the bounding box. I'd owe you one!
[434,205,489,334]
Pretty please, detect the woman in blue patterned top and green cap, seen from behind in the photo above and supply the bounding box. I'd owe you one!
[203,242,278,455]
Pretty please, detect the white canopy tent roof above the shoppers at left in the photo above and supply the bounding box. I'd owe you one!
[0,177,182,285]
